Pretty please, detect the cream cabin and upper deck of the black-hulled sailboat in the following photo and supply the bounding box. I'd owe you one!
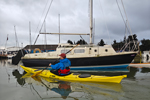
[24,43,116,59]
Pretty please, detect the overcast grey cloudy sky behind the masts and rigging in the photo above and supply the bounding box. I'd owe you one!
[0,0,150,47]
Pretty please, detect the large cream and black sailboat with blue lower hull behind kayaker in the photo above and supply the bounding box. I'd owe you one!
[22,0,138,71]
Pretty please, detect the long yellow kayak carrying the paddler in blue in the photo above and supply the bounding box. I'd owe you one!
[20,65,127,83]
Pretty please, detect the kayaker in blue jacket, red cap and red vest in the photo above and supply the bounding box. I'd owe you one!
[49,53,71,75]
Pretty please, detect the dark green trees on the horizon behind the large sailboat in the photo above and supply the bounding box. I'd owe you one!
[67,34,150,51]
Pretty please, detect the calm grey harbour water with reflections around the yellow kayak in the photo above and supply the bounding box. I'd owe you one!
[0,60,150,100]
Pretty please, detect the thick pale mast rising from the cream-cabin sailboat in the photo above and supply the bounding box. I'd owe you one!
[90,0,93,44]
